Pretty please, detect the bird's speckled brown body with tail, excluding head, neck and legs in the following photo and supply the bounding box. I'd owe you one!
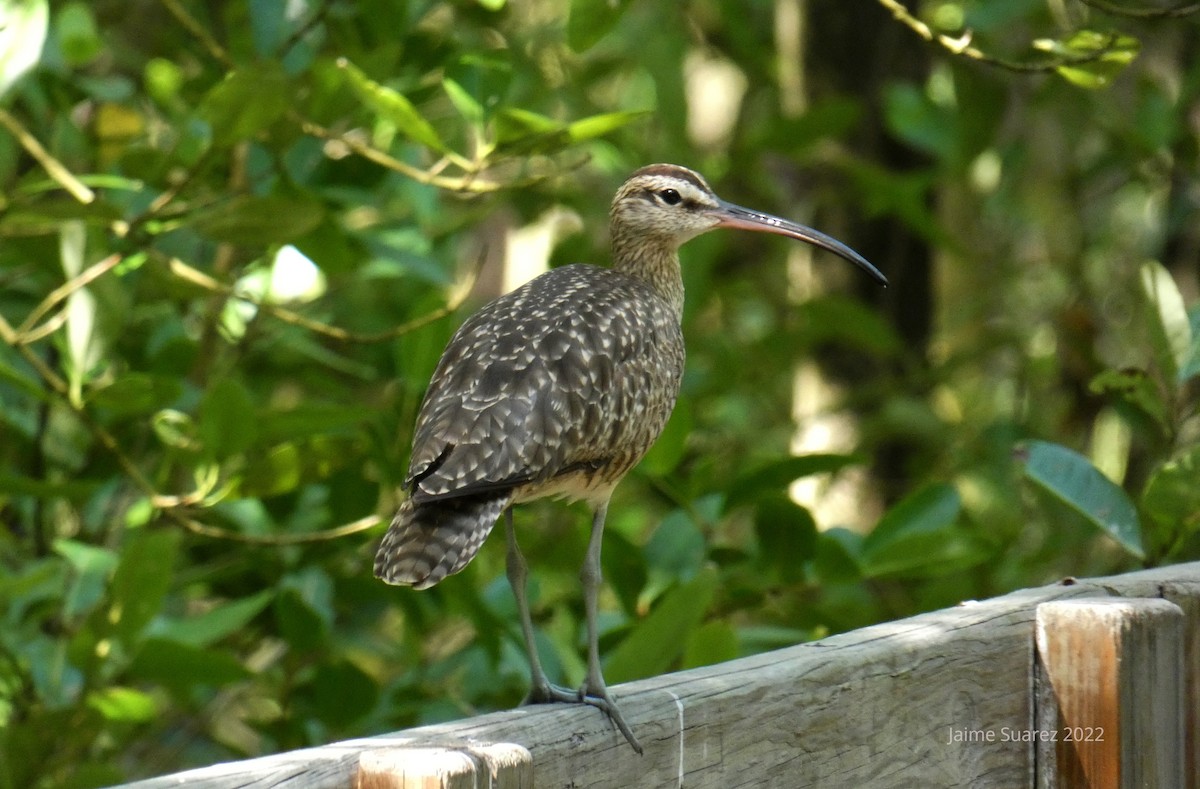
[376,265,684,589]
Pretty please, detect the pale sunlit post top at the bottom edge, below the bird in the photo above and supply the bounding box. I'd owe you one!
[354,742,533,789]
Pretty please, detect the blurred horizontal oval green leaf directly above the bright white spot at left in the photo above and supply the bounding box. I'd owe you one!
[191,194,325,246]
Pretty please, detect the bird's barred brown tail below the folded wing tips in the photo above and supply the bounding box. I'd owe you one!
[374,494,511,589]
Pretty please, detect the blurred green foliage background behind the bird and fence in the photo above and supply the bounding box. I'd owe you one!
[0,0,1200,788]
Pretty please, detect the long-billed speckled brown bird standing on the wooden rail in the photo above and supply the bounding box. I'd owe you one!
[374,164,887,754]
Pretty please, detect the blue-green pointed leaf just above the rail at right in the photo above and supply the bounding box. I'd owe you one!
[1019,441,1145,559]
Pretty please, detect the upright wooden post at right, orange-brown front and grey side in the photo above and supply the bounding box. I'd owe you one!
[1037,597,1184,789]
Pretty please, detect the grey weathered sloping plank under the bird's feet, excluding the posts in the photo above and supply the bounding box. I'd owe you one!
[119,562,1200,789]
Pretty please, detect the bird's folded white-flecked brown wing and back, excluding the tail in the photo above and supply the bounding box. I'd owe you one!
[406,261,683,501]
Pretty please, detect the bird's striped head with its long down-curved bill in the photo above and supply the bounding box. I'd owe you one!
[612,164,888,285]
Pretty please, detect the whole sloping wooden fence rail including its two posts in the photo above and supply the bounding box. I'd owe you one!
[127,562,1200,789]
